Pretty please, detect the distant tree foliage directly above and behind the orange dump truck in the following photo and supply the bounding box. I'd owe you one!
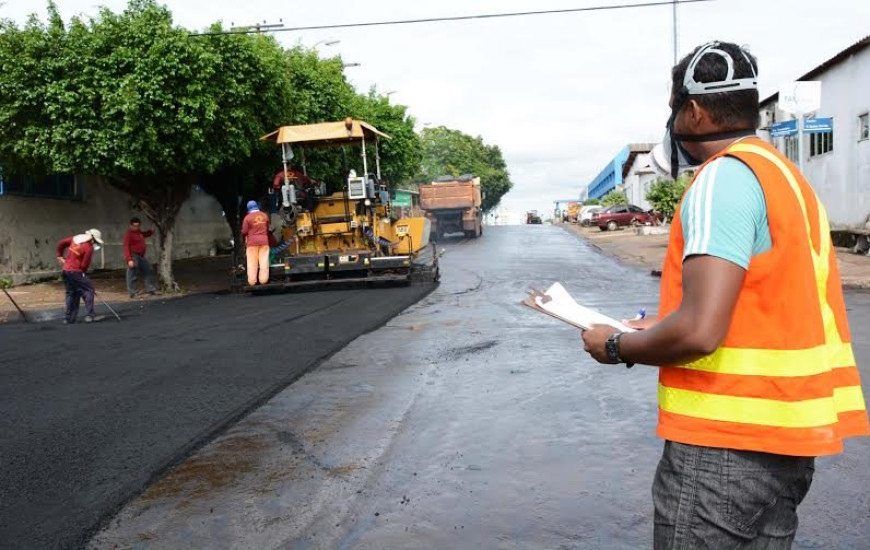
[417,126,513,211]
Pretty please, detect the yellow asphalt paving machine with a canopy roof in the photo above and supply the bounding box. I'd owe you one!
[238,118,439,292]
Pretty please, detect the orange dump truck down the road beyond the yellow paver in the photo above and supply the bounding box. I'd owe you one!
[420,175,483,240]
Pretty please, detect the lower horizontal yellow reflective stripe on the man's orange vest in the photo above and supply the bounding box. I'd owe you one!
[659,384,840,428]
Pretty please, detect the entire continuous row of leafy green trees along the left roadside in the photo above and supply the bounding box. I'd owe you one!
[0,0,512,286]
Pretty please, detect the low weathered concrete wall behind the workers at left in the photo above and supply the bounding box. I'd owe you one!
[0,176,232,284]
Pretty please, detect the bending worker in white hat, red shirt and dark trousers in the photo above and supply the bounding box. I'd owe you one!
[57,229,103,324]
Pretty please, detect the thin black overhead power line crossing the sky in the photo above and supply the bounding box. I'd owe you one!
[191,0,715,36]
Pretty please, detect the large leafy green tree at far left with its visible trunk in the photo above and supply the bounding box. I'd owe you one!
[0,0,289,288]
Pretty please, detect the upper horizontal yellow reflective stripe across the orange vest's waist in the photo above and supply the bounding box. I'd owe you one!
[680,343,855,376]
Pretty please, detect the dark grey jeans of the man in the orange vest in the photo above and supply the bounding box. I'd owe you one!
[652,441,815,550]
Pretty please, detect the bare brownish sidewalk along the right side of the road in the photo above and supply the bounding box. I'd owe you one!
[562,224,870,290]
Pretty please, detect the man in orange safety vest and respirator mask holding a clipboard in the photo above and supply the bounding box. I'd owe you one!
[583,42,870,550]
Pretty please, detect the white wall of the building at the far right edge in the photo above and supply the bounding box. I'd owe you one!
[761,48,870,227]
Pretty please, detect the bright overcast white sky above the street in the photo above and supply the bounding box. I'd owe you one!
[6,0,870,218]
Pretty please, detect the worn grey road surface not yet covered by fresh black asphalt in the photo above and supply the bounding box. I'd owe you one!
[83,226,870,550]
